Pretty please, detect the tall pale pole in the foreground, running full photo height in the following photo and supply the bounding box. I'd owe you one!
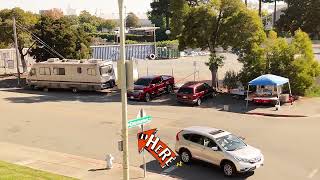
[118,0,129,180]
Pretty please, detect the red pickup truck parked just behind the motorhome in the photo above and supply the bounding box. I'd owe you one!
[128,75,174,102]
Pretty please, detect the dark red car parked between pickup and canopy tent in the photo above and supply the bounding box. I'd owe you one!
[177,82,216,106]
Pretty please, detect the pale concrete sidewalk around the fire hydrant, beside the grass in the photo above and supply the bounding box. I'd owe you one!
[0,142,174,180]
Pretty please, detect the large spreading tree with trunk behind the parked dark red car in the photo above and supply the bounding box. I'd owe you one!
[179,0,265,85]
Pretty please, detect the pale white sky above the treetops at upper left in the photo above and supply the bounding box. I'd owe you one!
[0,0,152,18]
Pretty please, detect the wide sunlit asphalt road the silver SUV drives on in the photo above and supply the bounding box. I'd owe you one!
[0,89,320,180]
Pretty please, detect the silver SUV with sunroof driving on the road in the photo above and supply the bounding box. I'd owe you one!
[175,127,264,176]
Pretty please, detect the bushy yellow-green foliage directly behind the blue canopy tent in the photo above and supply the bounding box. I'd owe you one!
[240,30,320,95]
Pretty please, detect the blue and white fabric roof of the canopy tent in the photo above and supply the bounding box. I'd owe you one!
[249,74,289,86]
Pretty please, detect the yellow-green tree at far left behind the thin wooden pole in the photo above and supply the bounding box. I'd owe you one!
[0,8,39,72]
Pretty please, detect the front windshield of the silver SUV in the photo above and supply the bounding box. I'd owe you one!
[216,134,247,151]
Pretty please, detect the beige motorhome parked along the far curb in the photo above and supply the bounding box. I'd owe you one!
[27,58,116,92]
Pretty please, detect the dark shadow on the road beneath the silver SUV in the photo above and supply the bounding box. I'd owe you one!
[140,160,254,180]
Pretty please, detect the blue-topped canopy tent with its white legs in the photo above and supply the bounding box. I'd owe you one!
[246,74,292,107]
